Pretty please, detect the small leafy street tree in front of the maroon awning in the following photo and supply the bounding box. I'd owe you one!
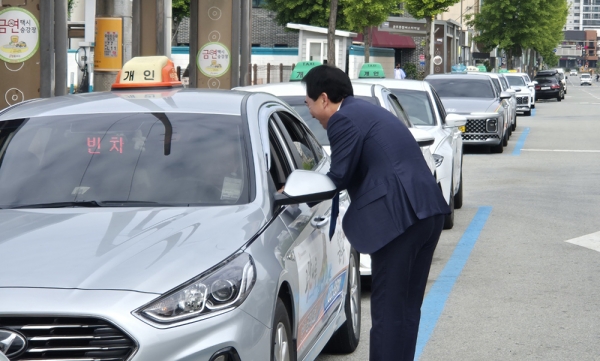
[341,0,401,63]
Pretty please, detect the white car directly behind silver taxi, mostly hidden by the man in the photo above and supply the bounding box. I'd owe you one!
[234,81,436,276]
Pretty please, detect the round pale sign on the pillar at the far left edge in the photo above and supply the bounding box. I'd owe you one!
[0,7,40,63]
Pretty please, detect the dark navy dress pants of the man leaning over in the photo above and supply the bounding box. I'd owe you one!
[369,215,444,361]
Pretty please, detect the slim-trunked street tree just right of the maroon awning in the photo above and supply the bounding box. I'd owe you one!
[404,0,462,74]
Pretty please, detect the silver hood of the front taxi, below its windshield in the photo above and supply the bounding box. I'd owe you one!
[0,205,265,293]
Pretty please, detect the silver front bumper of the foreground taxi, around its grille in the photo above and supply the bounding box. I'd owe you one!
[0,288,271,361]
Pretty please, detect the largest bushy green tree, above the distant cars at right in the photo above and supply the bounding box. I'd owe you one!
[467,0,568,69]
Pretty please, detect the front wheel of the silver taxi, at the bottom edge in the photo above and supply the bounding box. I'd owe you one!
[271,298,296,361]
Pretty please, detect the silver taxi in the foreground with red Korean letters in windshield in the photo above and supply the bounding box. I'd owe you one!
[0,56,360,361]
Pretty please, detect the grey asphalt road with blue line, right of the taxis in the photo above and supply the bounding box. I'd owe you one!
[317,76,600,361]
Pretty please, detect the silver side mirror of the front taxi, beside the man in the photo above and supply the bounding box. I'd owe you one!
[274,169,337,206]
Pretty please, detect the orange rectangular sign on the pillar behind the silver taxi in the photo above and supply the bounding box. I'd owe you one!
[94,18,123,71]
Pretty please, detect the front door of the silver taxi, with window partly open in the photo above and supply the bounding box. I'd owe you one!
[270,110,349,359]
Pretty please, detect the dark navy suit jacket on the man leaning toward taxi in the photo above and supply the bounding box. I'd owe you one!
[327,96,450,253]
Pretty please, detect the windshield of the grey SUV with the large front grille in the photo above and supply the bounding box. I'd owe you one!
[427,77,496,99]
